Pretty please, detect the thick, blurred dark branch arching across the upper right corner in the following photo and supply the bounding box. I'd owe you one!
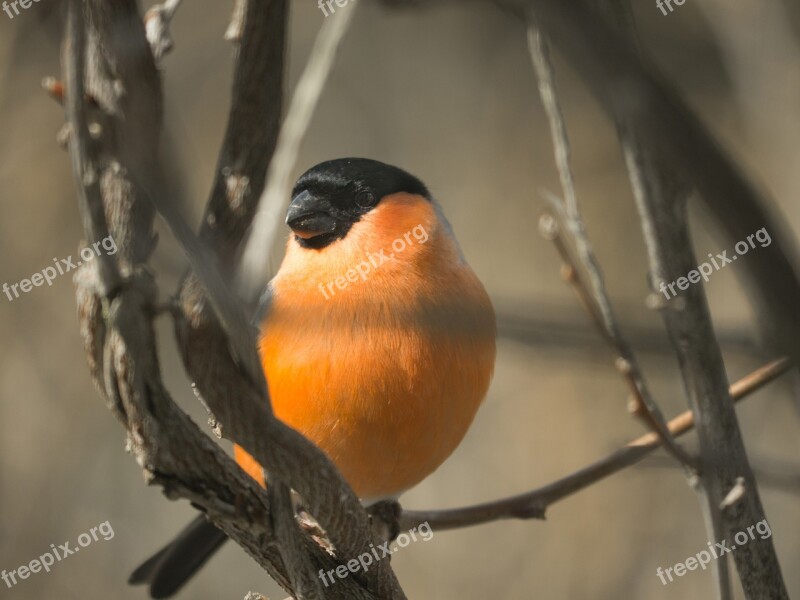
[520,0,800,362]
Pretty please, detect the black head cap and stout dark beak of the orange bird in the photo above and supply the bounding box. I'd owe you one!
[286,158,430,250]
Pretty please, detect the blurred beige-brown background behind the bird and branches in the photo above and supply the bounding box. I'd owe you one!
[0,0,800,600]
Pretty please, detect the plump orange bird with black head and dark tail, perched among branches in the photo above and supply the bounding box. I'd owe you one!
[129,158,496,598]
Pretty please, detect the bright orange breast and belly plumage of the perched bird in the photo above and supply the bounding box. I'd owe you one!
[237,194,495,500]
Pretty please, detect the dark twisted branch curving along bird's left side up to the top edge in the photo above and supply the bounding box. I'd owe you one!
[166,0,404,598]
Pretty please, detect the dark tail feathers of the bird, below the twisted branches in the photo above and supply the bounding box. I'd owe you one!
[128,515,228,598]
